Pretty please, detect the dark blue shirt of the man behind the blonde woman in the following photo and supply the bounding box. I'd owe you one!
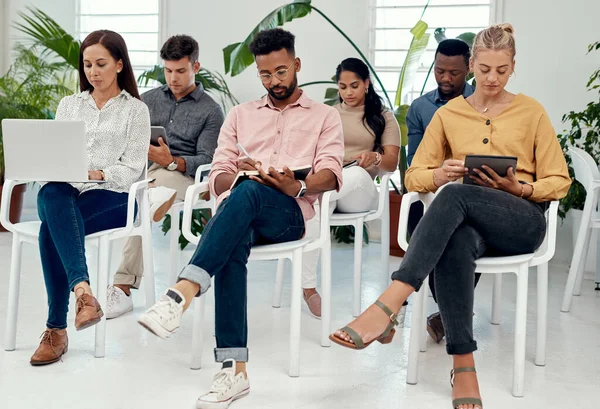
[406,83,475,166]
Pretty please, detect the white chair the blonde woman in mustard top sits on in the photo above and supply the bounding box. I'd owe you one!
[398,190,558,397]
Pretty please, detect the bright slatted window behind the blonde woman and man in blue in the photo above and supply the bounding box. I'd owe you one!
[369,0,495,104]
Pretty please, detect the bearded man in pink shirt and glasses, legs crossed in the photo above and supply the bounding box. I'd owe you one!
[138,28,344,409]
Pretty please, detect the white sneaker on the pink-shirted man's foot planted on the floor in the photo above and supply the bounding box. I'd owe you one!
[196,359,250,409]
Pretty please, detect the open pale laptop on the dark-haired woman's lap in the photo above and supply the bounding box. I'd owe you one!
[2,119,104,183]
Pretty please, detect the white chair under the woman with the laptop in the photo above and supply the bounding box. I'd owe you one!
[0,171,156,358]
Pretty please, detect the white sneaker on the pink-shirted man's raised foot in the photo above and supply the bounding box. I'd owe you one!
[138,288,185,339]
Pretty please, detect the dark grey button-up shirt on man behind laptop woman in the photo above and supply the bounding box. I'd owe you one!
[142,82,224,177]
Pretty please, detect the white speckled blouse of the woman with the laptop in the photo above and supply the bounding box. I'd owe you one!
[56,90,150,192]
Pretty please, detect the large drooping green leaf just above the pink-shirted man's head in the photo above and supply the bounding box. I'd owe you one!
[223,0,312,77]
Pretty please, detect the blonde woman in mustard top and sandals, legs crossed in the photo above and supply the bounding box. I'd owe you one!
[330,24,571,409]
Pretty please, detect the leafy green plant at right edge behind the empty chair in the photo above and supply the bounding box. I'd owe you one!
[558,41,600,270]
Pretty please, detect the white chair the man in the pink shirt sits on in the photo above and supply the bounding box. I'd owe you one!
[183,182,332,377]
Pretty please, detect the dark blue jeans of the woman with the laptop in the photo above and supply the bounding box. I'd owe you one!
[37,182,128,329]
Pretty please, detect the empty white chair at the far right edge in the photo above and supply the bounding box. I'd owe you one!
[560,146,600,312]
